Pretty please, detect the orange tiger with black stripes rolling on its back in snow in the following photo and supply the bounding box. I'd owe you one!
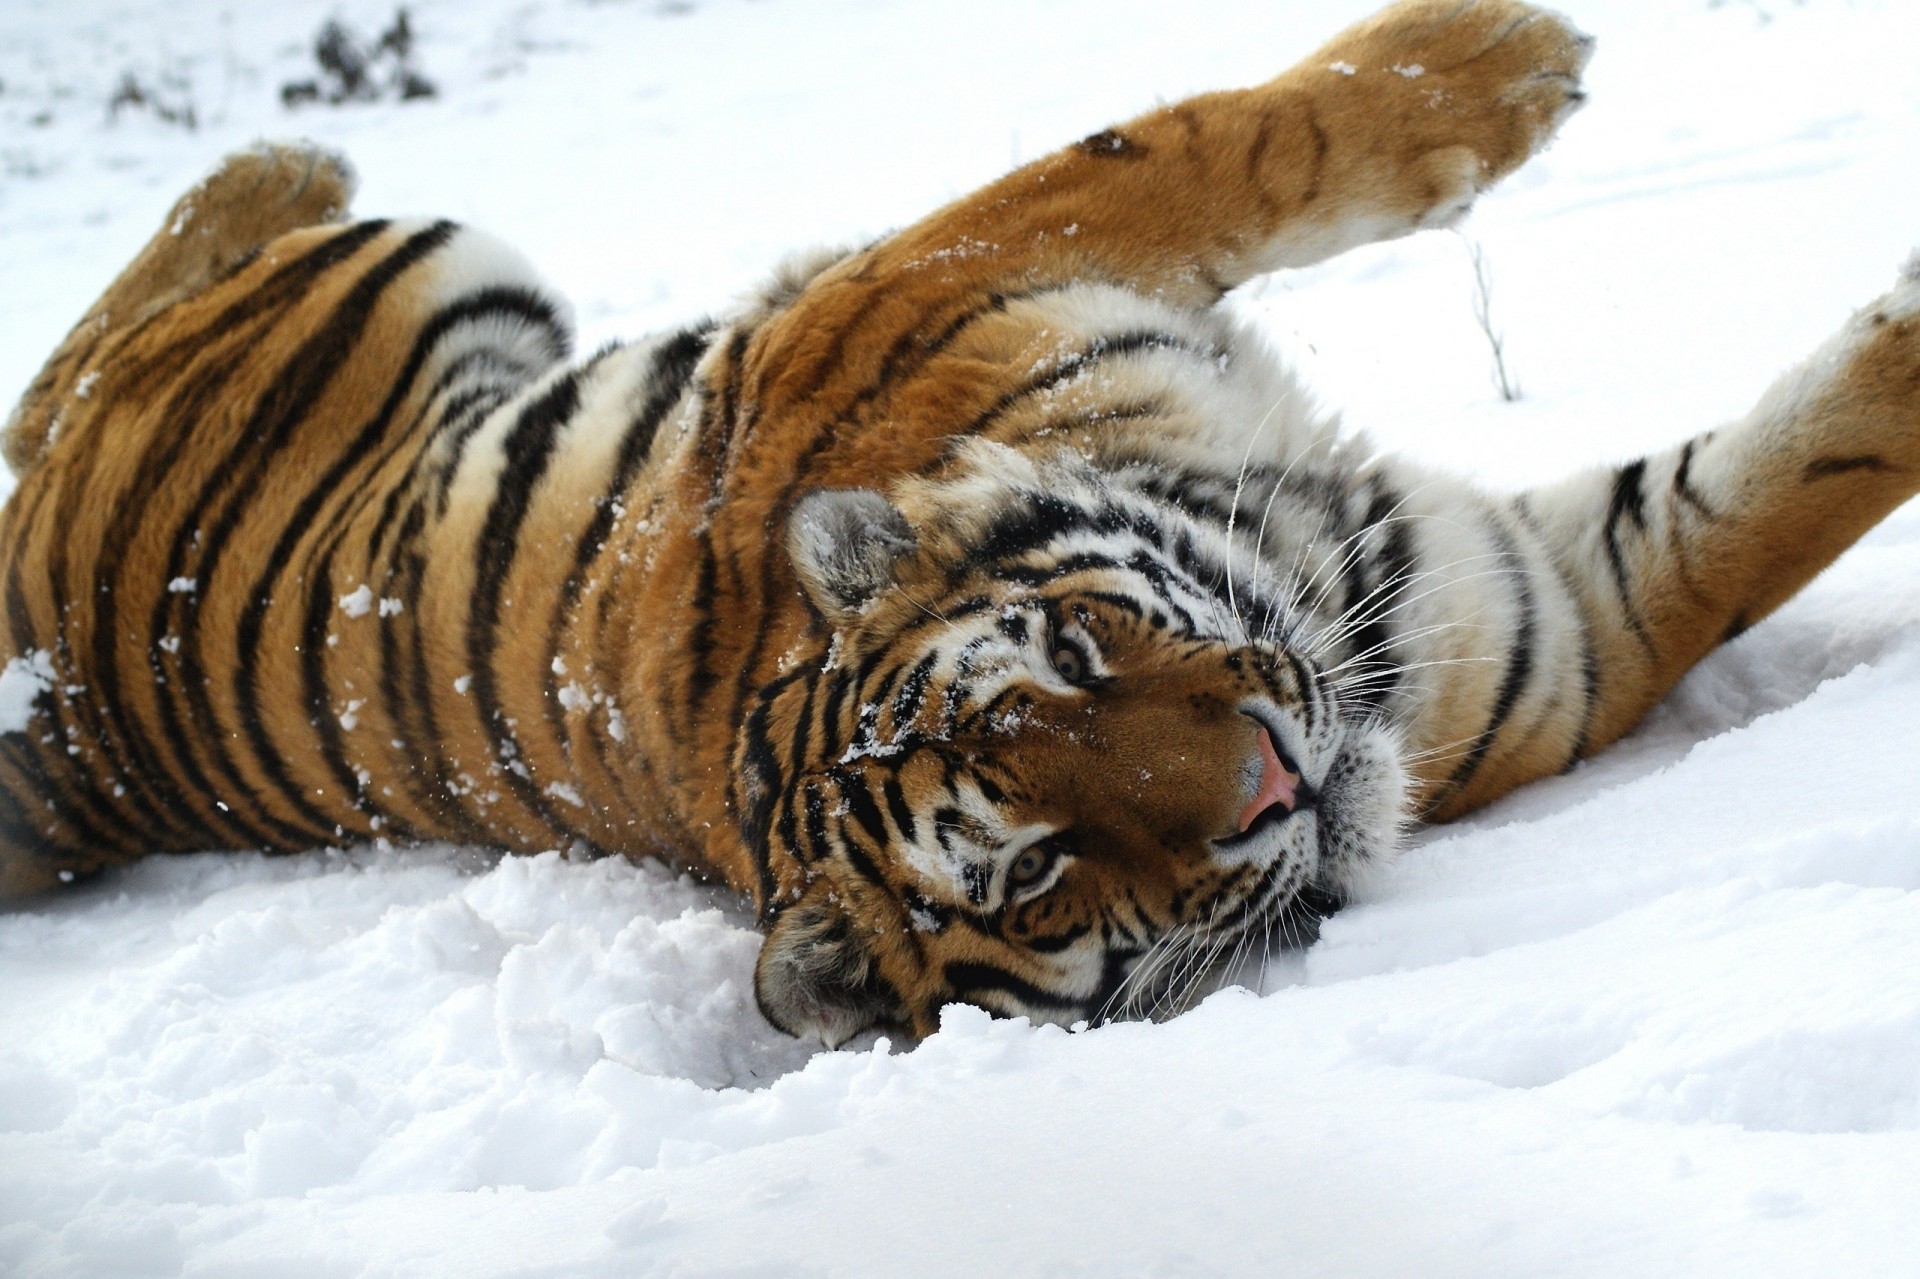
[0,0,1920,1045]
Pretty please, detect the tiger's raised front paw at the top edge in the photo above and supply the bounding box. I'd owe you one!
[1302,0,1594,227]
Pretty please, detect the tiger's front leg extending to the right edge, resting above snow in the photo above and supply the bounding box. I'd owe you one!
[1438,253,1920,816]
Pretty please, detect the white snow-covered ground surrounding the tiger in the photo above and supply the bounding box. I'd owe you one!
[0,0,1920,1279]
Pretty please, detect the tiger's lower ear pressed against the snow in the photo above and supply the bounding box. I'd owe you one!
[753,880,904,1049]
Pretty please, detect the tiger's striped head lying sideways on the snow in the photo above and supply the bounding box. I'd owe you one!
[735,446,1407,1045]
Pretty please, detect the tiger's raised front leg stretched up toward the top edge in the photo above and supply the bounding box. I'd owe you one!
[755,0,1592,413]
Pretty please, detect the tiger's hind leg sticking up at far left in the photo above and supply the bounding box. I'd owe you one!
[0,142,353,474]
